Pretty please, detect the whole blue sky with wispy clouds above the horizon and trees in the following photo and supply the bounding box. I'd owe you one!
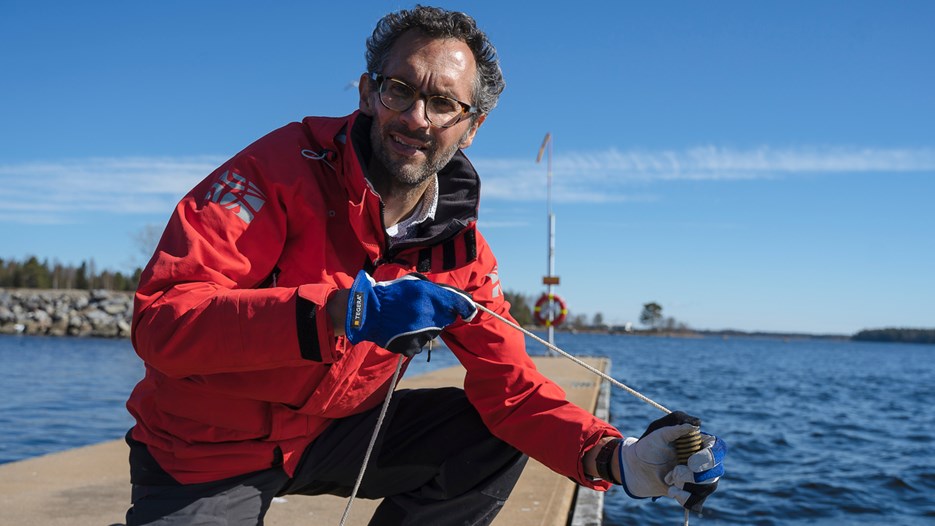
[0,0,935,333]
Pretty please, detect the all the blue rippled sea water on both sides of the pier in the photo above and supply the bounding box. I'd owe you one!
[0,333,935,526]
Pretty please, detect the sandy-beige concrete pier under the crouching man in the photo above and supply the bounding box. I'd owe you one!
[0,357,609,526]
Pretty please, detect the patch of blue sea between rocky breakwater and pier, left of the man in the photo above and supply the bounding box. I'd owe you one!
[0,335,143,463]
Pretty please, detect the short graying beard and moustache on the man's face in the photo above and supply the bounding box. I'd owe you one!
[370,119,471,189]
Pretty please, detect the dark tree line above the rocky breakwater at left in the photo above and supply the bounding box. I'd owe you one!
[0,256,143,291]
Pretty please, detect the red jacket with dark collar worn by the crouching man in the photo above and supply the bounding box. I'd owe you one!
[127,113,619,488]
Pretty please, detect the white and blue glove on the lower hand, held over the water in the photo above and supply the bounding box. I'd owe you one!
[617,411,727,513]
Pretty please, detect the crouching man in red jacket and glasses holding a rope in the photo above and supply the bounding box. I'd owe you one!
[127,7,722,526]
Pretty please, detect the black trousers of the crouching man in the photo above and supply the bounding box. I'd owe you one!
[127,388,526,526]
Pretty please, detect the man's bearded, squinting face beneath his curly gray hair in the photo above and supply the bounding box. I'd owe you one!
[360,31,484,187]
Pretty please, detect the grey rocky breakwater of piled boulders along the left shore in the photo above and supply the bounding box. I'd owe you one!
[0,289,133,338]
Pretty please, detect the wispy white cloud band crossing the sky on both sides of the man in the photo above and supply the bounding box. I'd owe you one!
[0,146,935,224]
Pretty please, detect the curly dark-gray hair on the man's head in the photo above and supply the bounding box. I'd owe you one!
[366,5,506,114]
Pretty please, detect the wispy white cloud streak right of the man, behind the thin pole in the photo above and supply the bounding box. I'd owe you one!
[474,146,935,203]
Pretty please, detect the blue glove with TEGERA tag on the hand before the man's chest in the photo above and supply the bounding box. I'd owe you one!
[344,270,477,357]
